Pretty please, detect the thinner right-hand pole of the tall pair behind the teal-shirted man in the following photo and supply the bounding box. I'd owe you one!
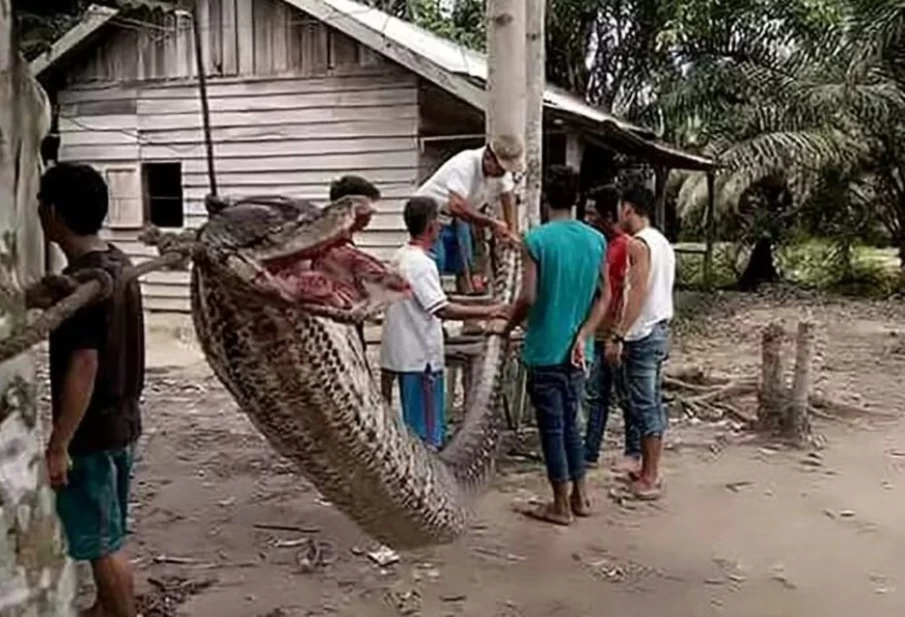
[519,0,544,229]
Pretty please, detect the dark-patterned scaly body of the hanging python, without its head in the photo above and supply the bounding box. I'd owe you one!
[191,195,519,549]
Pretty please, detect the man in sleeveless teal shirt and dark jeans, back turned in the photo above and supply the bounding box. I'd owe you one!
[505,165,609,525]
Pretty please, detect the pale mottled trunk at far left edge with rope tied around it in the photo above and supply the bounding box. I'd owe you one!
[0,0,75,617]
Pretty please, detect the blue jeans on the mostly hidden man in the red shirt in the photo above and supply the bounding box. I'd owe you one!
[584,342,641,463]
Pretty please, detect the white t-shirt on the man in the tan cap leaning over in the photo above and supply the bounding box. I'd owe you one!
[415,146,515,225]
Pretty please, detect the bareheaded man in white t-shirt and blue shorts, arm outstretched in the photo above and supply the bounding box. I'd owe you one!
[380,197,507,448]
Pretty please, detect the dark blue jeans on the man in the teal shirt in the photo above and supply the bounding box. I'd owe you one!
[528,364,585,482]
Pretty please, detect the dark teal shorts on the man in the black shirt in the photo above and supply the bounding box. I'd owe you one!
[57,444,135,561]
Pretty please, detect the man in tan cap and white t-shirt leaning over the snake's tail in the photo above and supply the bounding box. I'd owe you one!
[415,135,522,291]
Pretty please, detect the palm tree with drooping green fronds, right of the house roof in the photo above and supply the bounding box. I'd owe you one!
[658,0,905,278]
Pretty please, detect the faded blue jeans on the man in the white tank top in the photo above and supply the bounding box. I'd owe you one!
[618,321,669,438]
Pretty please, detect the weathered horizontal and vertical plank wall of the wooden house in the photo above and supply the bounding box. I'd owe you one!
[58,0,419,310]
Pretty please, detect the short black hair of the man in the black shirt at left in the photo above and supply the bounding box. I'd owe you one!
[38,163,110,236]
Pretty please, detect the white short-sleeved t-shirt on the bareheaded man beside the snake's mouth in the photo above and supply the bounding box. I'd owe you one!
[380,244,449,373]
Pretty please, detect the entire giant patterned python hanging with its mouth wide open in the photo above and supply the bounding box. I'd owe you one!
[191,197,518,549]
